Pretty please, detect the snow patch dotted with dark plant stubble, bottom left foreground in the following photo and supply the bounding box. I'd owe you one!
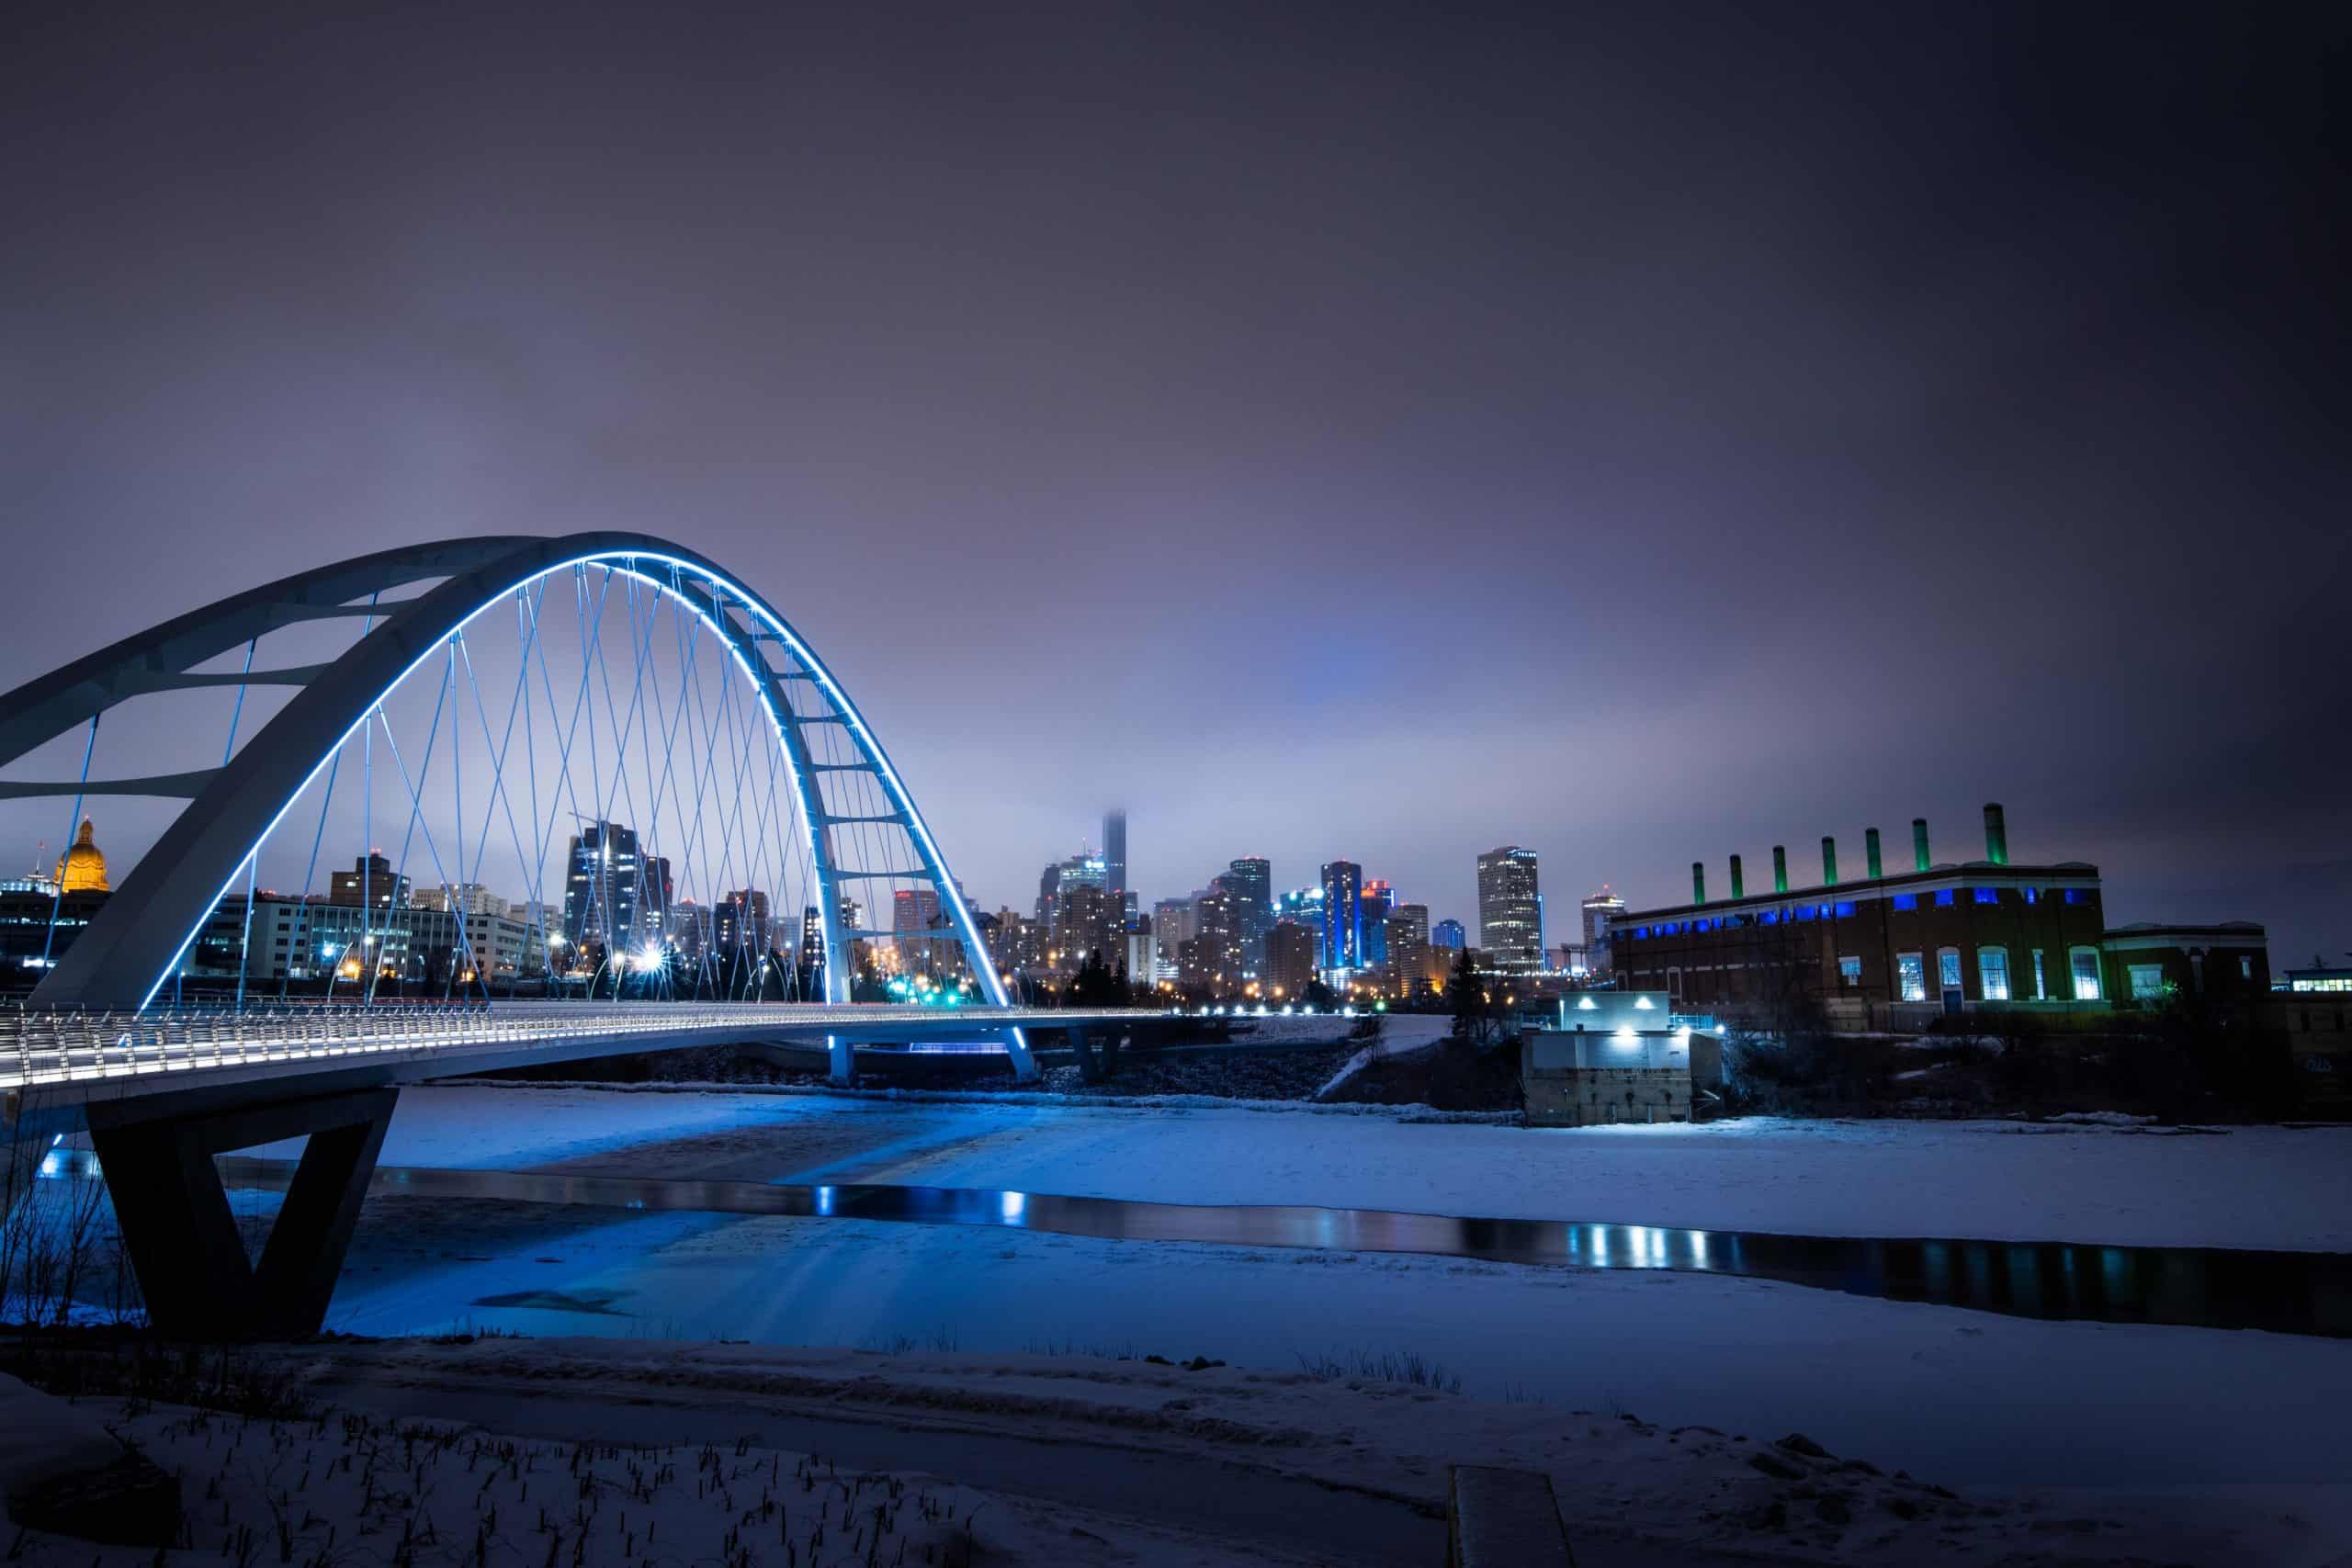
[28,1382,1298,1568]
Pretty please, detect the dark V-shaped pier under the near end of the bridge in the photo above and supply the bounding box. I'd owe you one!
[89,1089,400,1340]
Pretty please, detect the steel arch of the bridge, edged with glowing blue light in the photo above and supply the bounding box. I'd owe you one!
[0,531,1035,1077]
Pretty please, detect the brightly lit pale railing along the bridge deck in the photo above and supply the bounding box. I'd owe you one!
[0,1001,1158,1090]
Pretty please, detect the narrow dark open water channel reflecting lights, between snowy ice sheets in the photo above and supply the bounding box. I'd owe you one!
[178,1156,2352,1337]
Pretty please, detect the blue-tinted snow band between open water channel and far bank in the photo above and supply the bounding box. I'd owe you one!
[353,1086,2352,1251]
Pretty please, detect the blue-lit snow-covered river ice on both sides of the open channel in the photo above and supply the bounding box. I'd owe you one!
[192,1089,2352,1497]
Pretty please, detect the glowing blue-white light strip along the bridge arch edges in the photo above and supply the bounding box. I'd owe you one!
[139,550,1028,1051]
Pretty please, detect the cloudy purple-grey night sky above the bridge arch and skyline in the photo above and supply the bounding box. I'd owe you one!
[0,3,2352,964]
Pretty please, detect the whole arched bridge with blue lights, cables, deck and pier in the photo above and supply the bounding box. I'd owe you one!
[0,534,1167,1337]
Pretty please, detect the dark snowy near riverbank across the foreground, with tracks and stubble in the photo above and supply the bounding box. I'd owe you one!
[18,1337,2347,1568]
